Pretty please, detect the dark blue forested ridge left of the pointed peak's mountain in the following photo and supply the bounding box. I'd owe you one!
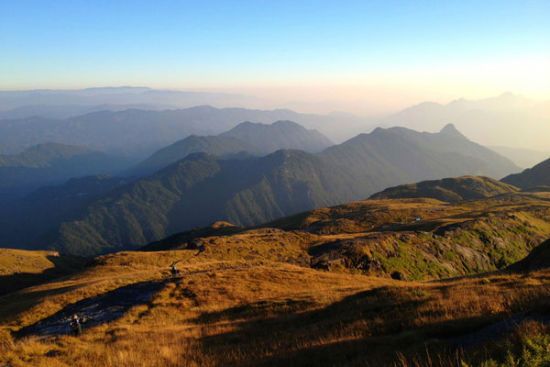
[50,151,354,254]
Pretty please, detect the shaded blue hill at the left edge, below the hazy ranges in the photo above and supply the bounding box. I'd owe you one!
[0,143,128,199]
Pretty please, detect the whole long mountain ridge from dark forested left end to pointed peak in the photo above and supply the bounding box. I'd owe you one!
[1,123,518,255]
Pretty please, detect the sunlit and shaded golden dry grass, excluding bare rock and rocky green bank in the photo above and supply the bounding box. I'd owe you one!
[0,194,550,367]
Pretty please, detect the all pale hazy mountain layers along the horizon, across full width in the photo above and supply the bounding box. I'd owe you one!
[0,87,550,157]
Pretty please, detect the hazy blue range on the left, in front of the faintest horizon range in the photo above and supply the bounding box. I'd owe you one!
[0,106,368,158]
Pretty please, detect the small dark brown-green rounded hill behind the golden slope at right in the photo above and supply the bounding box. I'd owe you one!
[370,176,518,202]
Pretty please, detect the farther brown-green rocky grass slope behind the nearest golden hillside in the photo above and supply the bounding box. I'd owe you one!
[146,193,550,280]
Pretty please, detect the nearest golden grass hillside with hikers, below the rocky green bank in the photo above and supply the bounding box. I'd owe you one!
[0,237,550,367]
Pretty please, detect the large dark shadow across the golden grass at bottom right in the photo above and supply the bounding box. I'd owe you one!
[195,287,548,366]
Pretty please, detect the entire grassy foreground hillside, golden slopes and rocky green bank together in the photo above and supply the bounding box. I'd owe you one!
[0,193,550,367]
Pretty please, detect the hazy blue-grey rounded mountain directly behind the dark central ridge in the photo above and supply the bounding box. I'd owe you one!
[131,121,332,175]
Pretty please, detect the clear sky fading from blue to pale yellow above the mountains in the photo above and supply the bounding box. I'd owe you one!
[0,0,550,112]
